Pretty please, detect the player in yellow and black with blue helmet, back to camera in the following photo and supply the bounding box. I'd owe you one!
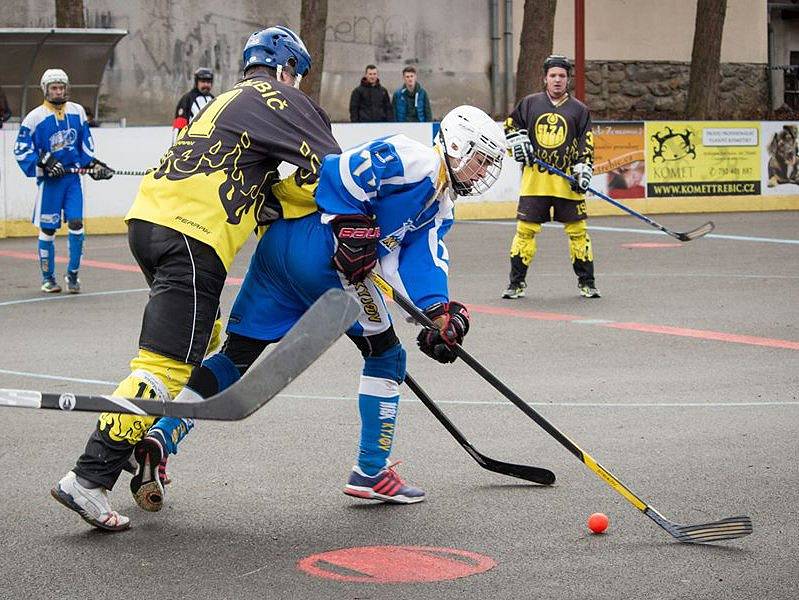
[51,27,341,531]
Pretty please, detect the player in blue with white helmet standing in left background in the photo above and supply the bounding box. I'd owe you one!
[14,69,114,294]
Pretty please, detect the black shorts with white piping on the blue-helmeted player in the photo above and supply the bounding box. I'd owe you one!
[128,219,227,366]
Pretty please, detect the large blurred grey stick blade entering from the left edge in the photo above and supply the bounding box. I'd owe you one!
[0,290,361,421]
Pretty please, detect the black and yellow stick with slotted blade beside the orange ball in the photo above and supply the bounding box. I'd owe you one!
[370,272,752,544]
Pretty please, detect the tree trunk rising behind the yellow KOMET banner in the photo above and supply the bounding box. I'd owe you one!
[685,0,727,119]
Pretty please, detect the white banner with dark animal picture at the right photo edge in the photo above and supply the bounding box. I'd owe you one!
[760,121,799,196]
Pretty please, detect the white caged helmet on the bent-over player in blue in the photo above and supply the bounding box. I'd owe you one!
[436,105,506,196]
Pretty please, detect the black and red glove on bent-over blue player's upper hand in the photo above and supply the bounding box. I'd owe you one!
[330,215,380,284]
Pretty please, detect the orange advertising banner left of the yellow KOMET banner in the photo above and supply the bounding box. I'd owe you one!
[591,121,646,199]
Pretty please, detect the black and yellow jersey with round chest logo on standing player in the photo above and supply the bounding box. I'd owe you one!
[505,92,594,200]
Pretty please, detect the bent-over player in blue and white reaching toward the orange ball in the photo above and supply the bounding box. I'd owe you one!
[142,106,505,504]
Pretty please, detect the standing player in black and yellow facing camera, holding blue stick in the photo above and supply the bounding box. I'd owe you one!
[502,55,599,299]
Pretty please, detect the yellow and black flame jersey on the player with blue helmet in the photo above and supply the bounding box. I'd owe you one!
[125,74,341,268]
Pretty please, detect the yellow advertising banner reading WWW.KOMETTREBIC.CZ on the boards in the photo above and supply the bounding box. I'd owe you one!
[646,121,761,198]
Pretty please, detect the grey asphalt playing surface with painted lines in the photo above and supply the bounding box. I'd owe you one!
[0,212,799,600]
